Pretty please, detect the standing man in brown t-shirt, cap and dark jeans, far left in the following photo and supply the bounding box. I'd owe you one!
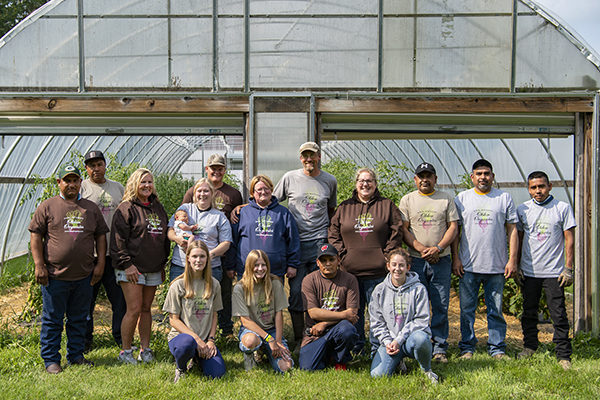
[29,165,109,374]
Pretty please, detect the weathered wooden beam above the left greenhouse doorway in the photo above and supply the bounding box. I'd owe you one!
[0,96,249,114]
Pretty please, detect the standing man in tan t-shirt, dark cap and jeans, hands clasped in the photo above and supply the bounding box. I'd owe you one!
[399,162,458,363]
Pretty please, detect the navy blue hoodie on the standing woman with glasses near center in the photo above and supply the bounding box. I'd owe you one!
[233,196,300,278]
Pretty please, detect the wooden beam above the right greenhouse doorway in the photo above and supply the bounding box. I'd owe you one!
[316,96,594,113]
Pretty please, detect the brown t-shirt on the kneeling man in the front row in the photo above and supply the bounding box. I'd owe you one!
[302,270,359,346]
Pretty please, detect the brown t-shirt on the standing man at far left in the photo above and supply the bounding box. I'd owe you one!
[29,196,109,281]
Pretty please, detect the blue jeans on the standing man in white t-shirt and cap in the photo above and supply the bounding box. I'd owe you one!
[458,271,506,356]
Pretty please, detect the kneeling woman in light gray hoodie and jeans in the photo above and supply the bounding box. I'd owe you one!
[369,248,438,384]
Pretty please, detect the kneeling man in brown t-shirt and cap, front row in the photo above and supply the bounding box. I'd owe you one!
[298,244,359,370]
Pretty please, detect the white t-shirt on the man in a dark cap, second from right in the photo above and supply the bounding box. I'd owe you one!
[454,188,518,274]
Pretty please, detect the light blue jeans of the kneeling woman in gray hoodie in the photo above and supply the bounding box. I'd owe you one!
[371,331,431,378]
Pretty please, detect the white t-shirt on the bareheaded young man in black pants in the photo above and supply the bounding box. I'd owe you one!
[517,199,577,278]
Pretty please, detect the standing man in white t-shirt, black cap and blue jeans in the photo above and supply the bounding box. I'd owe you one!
[452,159,519,360]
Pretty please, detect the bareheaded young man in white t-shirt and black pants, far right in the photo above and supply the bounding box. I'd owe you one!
[517,171,577,369]
